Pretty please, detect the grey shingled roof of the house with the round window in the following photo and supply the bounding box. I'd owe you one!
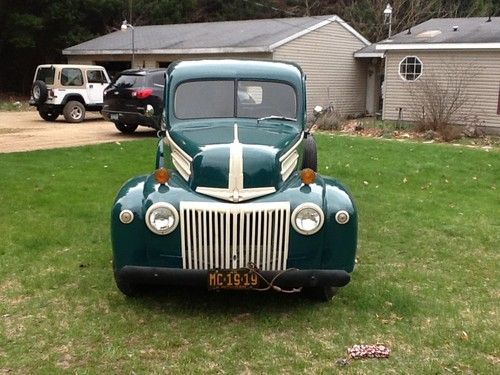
[376,17,500,51]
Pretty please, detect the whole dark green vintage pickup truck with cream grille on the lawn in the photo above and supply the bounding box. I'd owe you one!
[111,60,357,301]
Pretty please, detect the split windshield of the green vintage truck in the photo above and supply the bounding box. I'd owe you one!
[174,80,297,121]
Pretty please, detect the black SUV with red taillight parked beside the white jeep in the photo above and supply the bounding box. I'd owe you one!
[102,69,165,133]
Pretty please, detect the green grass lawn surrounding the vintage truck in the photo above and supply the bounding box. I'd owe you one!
[0,135,500,374]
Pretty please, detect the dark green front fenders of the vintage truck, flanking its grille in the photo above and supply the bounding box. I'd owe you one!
[112,170,357,272]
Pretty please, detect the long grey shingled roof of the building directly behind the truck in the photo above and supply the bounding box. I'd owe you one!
[63,15,370,55]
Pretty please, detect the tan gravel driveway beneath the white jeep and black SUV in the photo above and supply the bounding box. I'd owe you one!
[0,111,156,153]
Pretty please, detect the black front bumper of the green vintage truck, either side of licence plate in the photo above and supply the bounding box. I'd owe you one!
[115,266,351,289]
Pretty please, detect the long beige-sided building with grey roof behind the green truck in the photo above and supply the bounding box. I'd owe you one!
[63,15,374,115]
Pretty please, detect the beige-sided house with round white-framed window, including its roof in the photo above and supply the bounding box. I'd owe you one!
[376,17,500,134]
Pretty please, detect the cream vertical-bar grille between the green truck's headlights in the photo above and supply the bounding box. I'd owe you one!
[180,202,290,271]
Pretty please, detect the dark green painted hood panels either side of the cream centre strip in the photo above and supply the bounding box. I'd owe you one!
[169,119,301,190]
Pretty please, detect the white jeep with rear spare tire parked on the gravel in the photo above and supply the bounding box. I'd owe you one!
[29,64,110,122]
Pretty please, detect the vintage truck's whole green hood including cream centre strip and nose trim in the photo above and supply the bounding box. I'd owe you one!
[169,122,302,202]
